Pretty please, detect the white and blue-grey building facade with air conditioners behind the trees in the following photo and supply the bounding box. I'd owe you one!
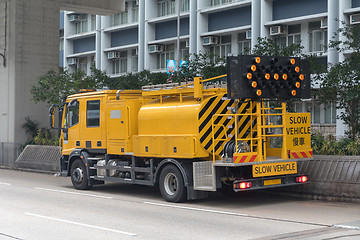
[60,0,360,136]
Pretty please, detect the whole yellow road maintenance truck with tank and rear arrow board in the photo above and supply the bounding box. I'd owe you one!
[50,55,312,202]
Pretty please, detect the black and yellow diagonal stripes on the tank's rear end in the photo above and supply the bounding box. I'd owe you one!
[198,94,256,155]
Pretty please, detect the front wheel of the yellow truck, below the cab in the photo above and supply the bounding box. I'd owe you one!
[70,159,92,190]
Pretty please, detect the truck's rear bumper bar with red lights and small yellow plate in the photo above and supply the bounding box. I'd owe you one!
[233,174,309,192]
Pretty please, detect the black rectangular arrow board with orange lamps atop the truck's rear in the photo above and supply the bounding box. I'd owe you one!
[227,55,311,100]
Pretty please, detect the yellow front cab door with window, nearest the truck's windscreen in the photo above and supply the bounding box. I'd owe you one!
[61,99,80,155]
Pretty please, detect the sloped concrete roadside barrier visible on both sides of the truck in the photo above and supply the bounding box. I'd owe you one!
[11,145,360,201]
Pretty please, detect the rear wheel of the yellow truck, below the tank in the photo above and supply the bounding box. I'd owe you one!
[159,165,187,203]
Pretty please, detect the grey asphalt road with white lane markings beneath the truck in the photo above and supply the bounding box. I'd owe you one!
[0,169,360,240]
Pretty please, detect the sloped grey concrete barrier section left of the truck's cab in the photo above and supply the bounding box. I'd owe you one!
[14,145,61,172]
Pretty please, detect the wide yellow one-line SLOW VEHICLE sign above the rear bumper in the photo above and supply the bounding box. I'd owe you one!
[252,162,297,177]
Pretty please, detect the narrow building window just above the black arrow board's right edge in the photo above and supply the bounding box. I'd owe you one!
[309,22,327,53]
